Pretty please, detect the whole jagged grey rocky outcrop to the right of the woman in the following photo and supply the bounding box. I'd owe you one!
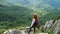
[43,19,60,34]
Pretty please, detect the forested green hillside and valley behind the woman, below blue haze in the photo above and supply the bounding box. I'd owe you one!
[0,5,60,33]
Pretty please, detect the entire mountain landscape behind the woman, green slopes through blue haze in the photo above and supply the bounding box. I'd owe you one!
[0,0,60,33]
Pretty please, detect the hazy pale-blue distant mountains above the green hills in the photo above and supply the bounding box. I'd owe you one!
[0,0,60,8]
